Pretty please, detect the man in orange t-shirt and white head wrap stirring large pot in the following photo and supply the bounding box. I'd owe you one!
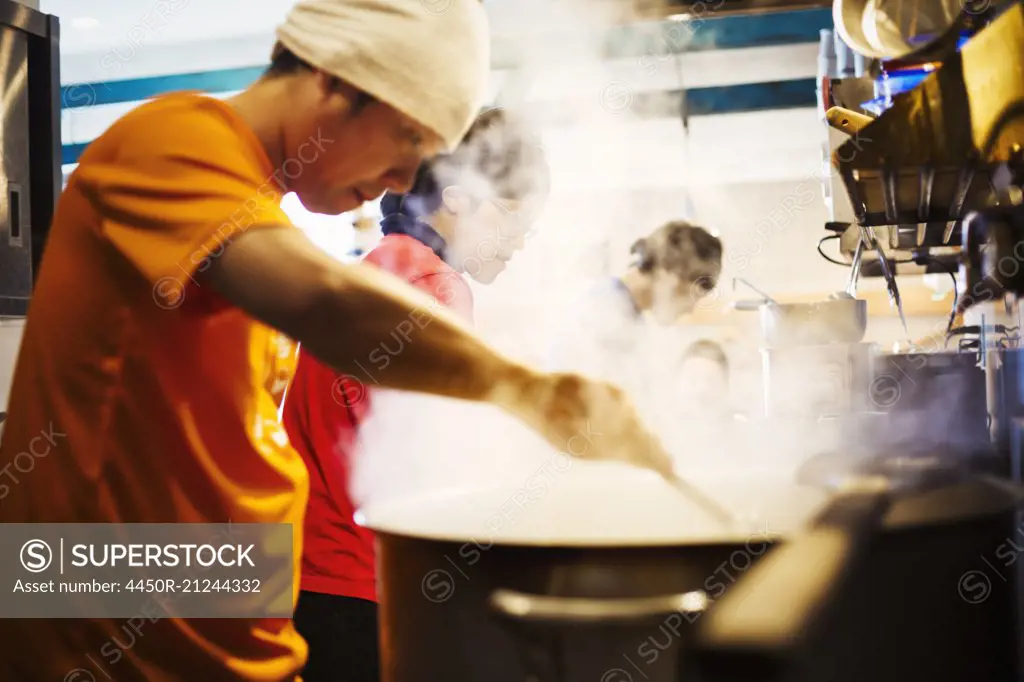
[0,0,671,682]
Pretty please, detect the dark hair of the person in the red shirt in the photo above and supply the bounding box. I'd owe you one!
[381,109,551,218]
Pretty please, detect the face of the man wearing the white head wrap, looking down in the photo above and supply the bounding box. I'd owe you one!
[280,74,442,215]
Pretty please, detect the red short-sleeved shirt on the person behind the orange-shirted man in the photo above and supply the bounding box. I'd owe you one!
[284,235,473,601]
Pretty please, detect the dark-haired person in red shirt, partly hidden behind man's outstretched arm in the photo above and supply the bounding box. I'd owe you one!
[283,110,549,682]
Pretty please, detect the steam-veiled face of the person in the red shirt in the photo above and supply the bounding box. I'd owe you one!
[450,193,536,284]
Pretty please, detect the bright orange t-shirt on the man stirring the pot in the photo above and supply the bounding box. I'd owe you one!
[0,93,308,682]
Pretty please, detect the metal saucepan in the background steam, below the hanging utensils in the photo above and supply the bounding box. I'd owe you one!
[761,298,867,348]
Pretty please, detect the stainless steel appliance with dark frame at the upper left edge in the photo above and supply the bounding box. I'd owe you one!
[0,0,61,317]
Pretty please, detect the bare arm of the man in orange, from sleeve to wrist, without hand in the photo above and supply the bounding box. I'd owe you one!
[203,228,543,412]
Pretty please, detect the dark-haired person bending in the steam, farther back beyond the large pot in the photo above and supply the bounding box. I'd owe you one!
[551,220,722,388]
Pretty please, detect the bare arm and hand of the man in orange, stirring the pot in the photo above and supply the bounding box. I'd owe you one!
[199,226,672,475]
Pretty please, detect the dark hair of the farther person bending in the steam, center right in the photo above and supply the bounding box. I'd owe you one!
[630,220,722,292]
